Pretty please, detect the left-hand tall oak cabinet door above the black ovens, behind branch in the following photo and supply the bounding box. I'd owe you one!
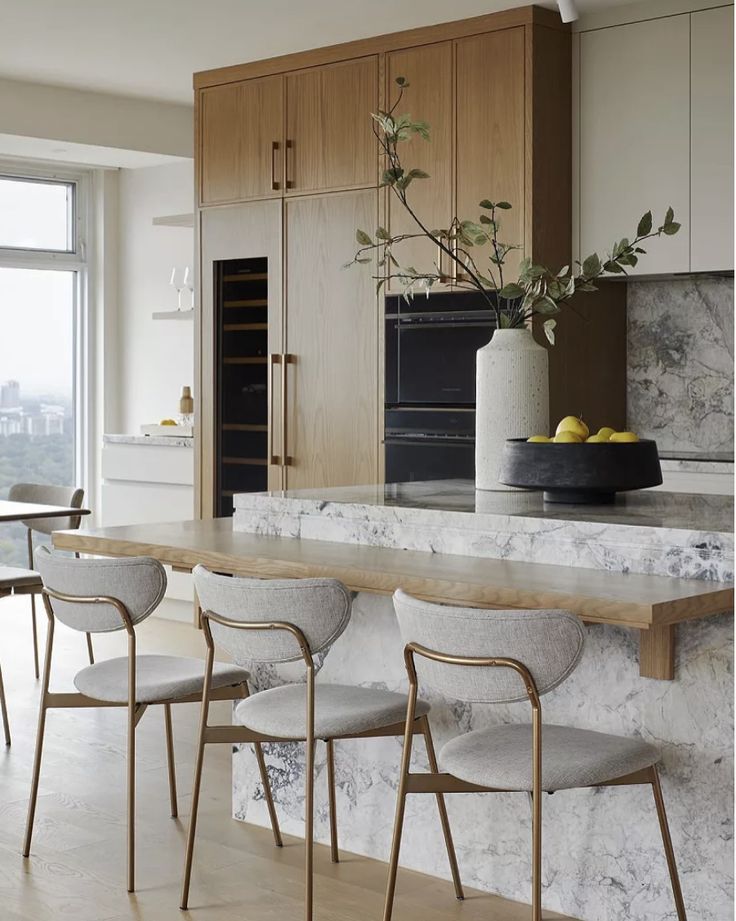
[387,42,453,291]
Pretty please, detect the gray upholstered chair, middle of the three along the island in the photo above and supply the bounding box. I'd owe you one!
[181,566,463,921]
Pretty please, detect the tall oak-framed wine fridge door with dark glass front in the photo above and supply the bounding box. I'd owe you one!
[196,201,283,518]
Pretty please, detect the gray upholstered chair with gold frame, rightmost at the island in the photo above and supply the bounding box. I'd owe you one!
[384,591,686,921]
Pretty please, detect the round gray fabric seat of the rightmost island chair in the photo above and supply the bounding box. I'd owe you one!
[439,723,660,791]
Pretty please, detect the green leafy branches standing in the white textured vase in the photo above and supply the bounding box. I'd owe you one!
[346,77,680,343]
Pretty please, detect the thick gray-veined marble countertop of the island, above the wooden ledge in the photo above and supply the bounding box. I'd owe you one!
[233,480,734,582]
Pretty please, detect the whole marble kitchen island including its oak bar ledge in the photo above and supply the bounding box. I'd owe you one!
[54,483,733,921]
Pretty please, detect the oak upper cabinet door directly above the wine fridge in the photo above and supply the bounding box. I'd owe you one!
[199,76,284,205]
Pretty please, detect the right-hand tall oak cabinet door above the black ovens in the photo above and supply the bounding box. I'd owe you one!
[456,27,525,281]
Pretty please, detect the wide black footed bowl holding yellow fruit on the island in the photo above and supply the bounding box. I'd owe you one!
[498,438,662,505]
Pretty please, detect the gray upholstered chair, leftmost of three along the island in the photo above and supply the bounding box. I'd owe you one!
[23,547,280,892]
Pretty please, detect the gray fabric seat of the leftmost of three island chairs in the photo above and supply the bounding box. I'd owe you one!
[74,656,248,704]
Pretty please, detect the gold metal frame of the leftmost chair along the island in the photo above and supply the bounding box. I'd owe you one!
[22,587,281,892]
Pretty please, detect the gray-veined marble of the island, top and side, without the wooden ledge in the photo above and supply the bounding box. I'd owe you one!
[233,484,733,921]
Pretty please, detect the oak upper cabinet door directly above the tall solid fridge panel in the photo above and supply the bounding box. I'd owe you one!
[286,56,378,194]
